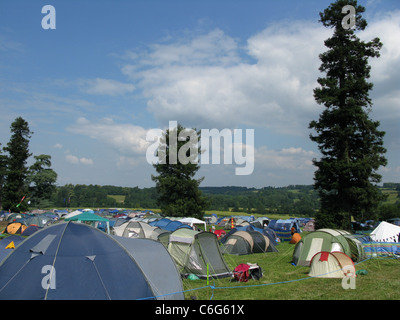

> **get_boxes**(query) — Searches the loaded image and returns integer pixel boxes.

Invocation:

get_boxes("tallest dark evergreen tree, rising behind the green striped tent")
[309,0,387,229]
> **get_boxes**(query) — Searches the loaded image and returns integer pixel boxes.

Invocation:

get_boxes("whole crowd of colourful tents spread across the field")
[0,206,400,300]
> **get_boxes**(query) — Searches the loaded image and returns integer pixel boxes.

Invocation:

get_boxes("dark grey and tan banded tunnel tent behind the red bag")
[220,228,278,255]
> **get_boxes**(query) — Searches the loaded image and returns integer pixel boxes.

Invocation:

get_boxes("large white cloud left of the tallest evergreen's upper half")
[123,22,328,133]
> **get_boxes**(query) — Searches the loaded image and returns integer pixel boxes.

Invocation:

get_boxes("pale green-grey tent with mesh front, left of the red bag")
[168,228,231,278]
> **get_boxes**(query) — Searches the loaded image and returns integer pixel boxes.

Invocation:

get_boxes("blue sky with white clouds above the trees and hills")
[0,0,400,188]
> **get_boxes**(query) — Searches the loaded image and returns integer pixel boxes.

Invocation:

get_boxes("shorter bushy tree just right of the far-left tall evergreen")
[28,154,57,206]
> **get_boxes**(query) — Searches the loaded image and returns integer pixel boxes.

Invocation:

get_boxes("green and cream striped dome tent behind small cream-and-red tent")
[293,229,365,266]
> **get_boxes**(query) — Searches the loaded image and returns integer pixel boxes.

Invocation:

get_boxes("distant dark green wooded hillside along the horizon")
[50,183,400,216]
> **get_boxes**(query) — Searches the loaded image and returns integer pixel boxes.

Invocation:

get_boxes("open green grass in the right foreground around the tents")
[183,242,400,300]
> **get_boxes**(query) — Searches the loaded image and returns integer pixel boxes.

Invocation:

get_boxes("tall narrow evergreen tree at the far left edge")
[3,117,33,212]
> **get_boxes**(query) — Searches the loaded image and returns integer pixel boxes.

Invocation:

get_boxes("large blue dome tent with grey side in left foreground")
[0,221,183,300]
